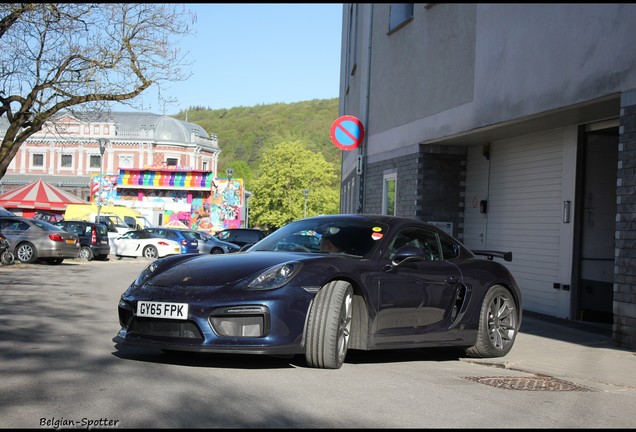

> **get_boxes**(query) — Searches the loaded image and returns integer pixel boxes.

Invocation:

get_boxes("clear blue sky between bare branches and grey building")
[122,3,342,115]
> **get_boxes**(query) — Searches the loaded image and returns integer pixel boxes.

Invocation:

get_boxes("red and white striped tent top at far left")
[0,180,86,212]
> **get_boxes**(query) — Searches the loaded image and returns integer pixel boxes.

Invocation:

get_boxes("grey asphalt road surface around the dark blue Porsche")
[0,258,636,428]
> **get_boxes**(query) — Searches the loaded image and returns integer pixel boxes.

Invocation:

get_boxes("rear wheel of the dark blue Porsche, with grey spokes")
[466,285,519,358]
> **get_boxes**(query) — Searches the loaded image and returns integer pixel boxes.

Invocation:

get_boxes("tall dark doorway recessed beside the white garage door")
[574,121,619,324]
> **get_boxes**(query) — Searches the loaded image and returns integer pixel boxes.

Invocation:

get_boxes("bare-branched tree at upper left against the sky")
[0,2,196,178]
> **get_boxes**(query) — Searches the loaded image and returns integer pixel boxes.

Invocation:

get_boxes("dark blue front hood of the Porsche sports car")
[146,252,328,288]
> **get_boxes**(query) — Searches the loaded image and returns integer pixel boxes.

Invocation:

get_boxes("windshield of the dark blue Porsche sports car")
[249,217,387,256]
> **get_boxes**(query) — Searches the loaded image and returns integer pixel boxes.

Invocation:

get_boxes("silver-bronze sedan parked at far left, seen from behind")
[0,216,80,264]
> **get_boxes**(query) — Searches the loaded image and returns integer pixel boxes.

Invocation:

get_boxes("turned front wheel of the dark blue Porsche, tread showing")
[305,281,353,369]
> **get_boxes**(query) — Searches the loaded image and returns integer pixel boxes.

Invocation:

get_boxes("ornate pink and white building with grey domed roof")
[0,112,221,202]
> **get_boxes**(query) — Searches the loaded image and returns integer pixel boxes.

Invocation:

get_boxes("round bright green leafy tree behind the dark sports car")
[250,141,340,228]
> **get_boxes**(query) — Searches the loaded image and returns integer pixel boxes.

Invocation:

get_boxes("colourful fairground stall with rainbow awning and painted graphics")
[91,166,245,232]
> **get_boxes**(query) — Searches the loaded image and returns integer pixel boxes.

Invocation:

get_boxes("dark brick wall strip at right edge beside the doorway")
[613,90,636,348]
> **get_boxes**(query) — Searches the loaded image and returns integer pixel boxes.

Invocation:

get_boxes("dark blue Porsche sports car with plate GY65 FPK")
[113,214,522,369]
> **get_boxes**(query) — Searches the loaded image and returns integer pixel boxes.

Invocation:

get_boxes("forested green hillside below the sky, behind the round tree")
[174,98,342,174]
